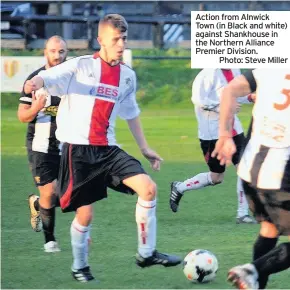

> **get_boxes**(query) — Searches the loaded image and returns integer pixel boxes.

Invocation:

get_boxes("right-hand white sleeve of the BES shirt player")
[118,73,140,120]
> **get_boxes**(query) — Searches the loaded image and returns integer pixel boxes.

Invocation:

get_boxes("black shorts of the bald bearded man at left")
[28,150,60,186]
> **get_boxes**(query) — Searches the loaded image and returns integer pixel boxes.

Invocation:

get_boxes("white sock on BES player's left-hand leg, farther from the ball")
[70,218,91,270]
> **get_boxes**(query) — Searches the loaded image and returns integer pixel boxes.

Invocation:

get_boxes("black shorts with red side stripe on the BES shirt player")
[57,143,146,212]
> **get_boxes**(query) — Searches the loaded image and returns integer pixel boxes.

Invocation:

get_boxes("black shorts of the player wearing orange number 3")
[242,180,290,236]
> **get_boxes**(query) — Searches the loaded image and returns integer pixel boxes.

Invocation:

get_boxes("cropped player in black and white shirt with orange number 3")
[212,69,290,289]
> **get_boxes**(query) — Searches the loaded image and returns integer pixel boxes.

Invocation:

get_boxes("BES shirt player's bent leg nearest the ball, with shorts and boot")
[106,147,182,267]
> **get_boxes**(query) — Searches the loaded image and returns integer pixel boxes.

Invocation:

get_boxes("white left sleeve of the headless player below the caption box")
[191,69,220,111]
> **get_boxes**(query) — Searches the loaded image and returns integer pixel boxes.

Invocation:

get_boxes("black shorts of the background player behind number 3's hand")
[200,133,245,173]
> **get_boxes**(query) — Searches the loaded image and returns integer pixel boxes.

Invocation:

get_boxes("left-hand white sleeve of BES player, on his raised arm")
[38,57,80,97]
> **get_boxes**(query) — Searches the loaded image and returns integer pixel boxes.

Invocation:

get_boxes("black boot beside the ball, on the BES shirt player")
[136,250,182,268]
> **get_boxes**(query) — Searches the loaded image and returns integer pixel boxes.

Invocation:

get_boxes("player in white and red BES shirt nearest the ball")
[25,14,181,282]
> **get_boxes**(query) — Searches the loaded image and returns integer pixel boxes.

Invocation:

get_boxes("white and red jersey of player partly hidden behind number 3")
[191,69,250,140]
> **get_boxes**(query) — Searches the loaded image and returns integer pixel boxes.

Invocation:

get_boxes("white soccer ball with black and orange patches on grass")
[183,250,218,283]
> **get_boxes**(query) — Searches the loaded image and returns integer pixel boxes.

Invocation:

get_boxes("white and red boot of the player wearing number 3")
[228,264,259,290]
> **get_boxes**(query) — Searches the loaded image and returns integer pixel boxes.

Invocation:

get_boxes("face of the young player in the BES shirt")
[98,26,127,60]
